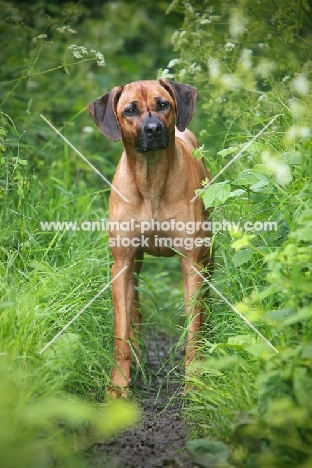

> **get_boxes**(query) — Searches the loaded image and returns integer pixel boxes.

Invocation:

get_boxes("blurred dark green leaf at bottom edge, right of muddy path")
[186,439,230,468]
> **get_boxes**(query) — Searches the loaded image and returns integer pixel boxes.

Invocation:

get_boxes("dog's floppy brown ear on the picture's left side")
[88,86,122,141]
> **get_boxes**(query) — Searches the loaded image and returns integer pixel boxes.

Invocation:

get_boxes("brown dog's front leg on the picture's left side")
[109,248,135,397]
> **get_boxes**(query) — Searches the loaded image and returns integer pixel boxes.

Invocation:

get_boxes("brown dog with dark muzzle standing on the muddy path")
[88,80,211,396]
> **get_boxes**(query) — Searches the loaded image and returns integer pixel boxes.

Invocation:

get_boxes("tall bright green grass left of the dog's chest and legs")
[0,130,137,468]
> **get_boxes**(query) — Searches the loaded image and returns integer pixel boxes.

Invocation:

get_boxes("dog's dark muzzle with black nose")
[135,117,169,153]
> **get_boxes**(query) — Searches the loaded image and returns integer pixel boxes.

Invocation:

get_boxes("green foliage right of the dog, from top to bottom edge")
[167,0,312,467]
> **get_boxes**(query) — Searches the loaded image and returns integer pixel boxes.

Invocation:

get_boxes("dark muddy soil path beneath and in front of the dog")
[84,333,193,468]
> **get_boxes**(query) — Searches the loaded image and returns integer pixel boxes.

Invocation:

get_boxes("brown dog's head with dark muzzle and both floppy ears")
[88,80,197,153]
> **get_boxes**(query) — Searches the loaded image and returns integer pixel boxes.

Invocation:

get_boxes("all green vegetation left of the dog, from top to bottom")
[0,0,183,460]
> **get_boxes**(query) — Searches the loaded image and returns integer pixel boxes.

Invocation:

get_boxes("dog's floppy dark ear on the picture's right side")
[159,80,197,132]
